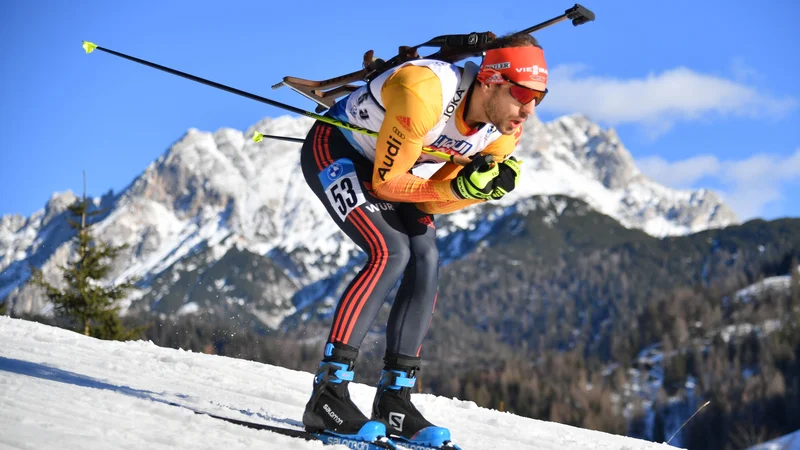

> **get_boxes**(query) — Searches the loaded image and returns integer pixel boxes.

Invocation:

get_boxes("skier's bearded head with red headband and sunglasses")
[475,33,547,134]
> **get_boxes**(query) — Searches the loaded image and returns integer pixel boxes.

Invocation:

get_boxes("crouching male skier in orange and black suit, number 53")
[301,33,547,447]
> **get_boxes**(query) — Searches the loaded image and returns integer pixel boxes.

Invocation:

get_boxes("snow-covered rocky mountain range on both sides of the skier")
[0,112,736,314]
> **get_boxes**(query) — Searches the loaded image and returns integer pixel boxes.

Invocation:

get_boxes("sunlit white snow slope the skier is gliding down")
[0,316,674,450]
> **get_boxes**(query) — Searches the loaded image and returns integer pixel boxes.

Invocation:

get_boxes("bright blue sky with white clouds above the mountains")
[0,0,800,220]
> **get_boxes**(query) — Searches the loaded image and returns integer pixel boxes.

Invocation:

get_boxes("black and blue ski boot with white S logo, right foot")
[372,354,460,450]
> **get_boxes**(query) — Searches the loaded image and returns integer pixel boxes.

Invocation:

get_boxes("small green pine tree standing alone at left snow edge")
[30,175,143,340]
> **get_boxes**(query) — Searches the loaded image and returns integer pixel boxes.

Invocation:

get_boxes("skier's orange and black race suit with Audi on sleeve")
[301,61,521,356]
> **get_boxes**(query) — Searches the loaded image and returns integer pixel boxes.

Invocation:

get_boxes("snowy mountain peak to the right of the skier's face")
[517,116,737,237]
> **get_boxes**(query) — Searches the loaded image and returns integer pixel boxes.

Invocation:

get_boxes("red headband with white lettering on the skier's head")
[478,45,547,91]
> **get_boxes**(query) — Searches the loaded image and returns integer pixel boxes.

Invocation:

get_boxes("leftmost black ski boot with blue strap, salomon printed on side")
[303,343,387,442]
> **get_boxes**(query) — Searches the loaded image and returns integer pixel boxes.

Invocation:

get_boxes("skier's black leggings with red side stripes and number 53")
[301,122,439,356]
